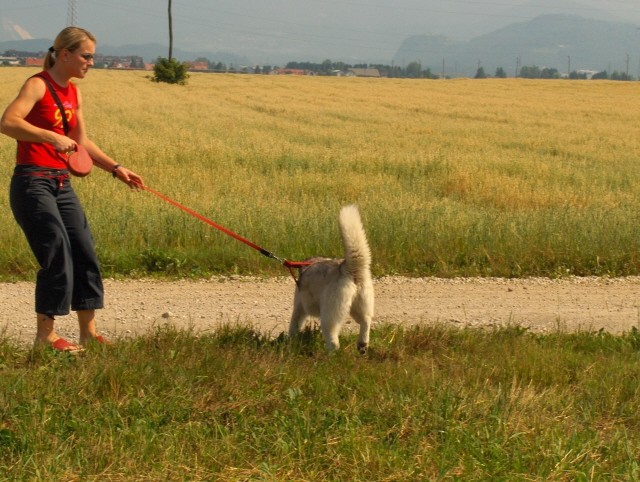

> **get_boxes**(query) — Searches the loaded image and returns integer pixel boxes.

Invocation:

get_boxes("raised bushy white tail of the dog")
[339,205,371,283]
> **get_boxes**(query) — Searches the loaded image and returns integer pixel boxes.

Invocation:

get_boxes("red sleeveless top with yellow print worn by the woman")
[17,71,78,169]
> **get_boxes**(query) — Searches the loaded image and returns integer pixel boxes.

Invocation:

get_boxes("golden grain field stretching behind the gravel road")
[0,68,640,279]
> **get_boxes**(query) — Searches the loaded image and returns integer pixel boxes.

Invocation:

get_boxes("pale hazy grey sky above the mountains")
[0,0,640,59]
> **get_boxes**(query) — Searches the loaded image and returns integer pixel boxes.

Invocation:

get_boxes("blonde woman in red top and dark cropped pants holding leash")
[0,27,144,352]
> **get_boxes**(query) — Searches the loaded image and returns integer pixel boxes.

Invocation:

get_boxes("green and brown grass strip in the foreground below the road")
[0,325,640,481]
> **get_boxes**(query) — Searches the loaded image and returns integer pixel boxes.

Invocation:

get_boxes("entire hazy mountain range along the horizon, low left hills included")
[0,14,640,77]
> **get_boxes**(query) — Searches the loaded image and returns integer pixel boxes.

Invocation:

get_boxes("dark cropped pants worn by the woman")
[10,166,104,317]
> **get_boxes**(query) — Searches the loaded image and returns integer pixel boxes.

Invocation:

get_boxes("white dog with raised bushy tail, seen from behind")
[289,205,373,353]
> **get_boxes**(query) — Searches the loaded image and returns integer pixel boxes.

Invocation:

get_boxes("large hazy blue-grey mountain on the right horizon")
[393,14,640,77]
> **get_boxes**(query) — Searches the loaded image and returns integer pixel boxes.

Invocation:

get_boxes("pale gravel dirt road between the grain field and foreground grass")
[0,277,640,343]
